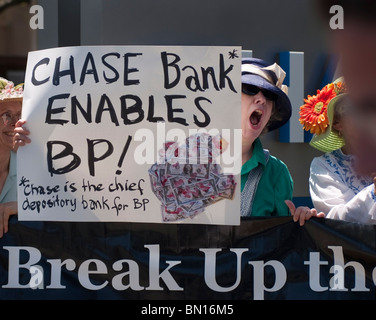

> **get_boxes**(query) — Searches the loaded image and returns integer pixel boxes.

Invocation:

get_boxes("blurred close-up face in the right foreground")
[334,21,376,174]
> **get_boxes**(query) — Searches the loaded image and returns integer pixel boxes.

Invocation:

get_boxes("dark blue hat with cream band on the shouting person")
[242,58,292,131]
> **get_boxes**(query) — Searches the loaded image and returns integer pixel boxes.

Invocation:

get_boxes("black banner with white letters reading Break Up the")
[0,217,376,300]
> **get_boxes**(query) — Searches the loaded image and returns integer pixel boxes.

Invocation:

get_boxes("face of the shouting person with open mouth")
[241,91,273,148]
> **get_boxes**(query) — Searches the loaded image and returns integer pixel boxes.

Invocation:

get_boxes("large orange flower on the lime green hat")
[299,83,337,134]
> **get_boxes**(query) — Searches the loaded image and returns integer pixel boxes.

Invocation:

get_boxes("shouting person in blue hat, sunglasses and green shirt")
[241,58,293,217]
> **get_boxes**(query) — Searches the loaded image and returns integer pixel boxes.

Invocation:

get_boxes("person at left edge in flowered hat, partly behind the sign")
[0,77,23,238]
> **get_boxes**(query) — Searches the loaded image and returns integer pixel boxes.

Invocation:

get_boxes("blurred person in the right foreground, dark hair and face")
[318,0,376,175]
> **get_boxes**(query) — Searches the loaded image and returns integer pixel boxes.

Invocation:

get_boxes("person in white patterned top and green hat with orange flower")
[287,77,376,225]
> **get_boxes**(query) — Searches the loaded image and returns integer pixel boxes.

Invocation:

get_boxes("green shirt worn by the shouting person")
[241,139,293,217]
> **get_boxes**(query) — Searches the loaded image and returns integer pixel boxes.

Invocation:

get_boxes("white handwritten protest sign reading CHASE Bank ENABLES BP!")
[17,46,241,225]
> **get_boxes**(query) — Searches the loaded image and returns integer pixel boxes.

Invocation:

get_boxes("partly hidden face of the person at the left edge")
[0,101,22,149]
